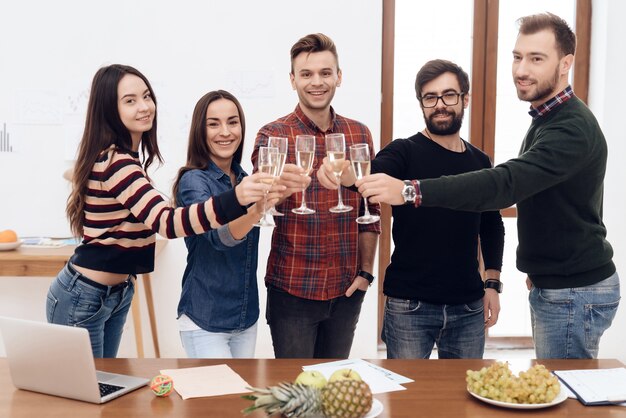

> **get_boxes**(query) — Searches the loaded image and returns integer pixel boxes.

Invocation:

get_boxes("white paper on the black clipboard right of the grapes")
[554,367,626,405]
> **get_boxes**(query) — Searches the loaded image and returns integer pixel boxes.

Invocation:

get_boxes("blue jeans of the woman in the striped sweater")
[46,264,135,358]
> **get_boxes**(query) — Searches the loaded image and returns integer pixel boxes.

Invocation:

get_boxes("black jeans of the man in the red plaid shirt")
[265,287,365,359]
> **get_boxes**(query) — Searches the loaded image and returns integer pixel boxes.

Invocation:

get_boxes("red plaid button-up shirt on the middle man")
[252,105,380,300]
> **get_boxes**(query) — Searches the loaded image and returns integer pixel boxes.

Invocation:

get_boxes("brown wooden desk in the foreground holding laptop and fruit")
[0,359,626,418]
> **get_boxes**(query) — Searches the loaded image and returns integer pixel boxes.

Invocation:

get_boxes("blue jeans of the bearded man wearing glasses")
[382,297,485,359]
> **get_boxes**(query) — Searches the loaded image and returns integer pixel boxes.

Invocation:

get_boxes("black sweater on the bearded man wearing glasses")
[372,133,504,304]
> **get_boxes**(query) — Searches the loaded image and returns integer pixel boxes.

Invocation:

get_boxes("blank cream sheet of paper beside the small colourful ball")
[161,364,251,399]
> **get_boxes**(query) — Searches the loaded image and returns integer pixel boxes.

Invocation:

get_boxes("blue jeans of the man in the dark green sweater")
[528,272,620,359]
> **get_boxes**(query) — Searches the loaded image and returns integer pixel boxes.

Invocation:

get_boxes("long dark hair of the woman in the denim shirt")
[172,90,246,204]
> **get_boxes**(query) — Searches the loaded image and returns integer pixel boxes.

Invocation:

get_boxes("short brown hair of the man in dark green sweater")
[517,13,576,58]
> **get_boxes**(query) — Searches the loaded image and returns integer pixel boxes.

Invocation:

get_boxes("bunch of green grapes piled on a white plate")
[465,362,561,404]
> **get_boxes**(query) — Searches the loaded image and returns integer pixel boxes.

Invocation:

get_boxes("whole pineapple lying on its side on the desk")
[242,379,373,418]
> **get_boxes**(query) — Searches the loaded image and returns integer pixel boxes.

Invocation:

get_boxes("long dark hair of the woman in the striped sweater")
[65,64,163,236]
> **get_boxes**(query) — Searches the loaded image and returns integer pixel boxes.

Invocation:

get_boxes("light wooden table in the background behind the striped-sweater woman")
[0,239,167,358]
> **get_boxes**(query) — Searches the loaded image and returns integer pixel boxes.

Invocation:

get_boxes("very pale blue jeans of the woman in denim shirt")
[180,322,257,358]
